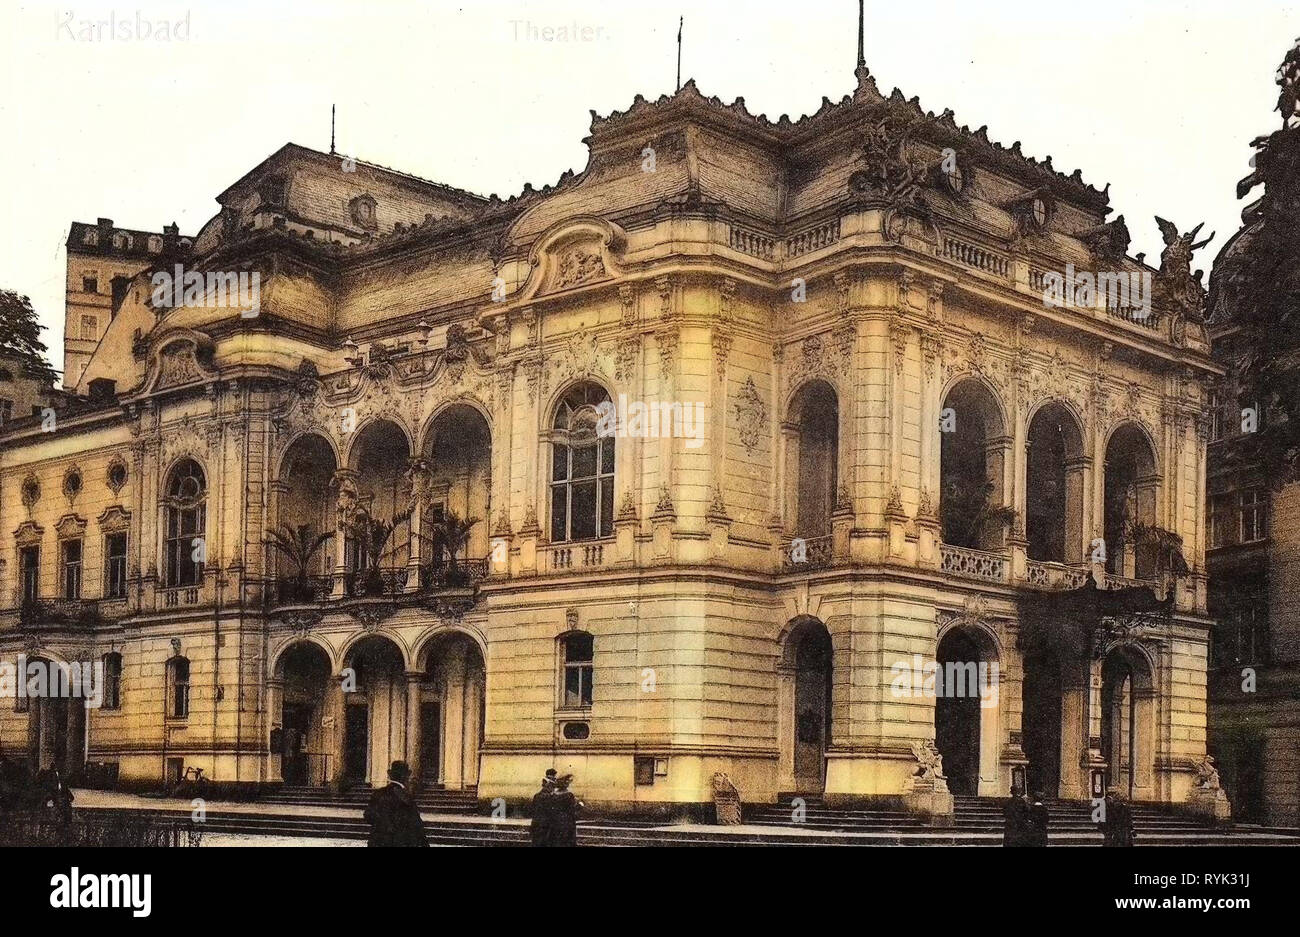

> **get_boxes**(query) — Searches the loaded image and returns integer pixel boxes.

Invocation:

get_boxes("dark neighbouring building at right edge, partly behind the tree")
[1206,215,1300,827]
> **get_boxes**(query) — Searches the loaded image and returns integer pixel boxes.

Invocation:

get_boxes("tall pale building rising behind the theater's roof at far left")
[64,218,186,394]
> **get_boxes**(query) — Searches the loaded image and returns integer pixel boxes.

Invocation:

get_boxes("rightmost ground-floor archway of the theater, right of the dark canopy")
[1101,645,1156,801]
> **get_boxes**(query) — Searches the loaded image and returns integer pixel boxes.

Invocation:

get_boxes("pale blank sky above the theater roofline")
[0,0,1300,368]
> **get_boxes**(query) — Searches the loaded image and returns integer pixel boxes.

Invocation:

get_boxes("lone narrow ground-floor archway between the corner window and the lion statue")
[779,616,835,794]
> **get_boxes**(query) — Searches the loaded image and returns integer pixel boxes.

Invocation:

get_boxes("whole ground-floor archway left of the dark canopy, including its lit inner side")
[935,624,1001,795]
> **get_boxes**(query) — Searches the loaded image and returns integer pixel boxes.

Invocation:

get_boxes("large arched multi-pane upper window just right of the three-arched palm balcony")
[551,383,614,542]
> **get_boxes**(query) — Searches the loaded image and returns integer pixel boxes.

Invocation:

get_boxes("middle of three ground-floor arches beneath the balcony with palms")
[341,634,407,785]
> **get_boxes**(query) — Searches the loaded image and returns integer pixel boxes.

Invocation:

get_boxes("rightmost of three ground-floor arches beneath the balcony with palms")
[410,630,488,790]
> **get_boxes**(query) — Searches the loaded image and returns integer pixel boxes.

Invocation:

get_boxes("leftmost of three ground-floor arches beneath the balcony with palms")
[272,641,333,786]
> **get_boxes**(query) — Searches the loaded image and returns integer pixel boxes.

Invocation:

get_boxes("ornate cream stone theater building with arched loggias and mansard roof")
[0,65,1221,814]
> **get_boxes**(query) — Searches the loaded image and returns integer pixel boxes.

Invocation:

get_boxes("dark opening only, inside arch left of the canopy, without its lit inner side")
[935,632,980,795]
